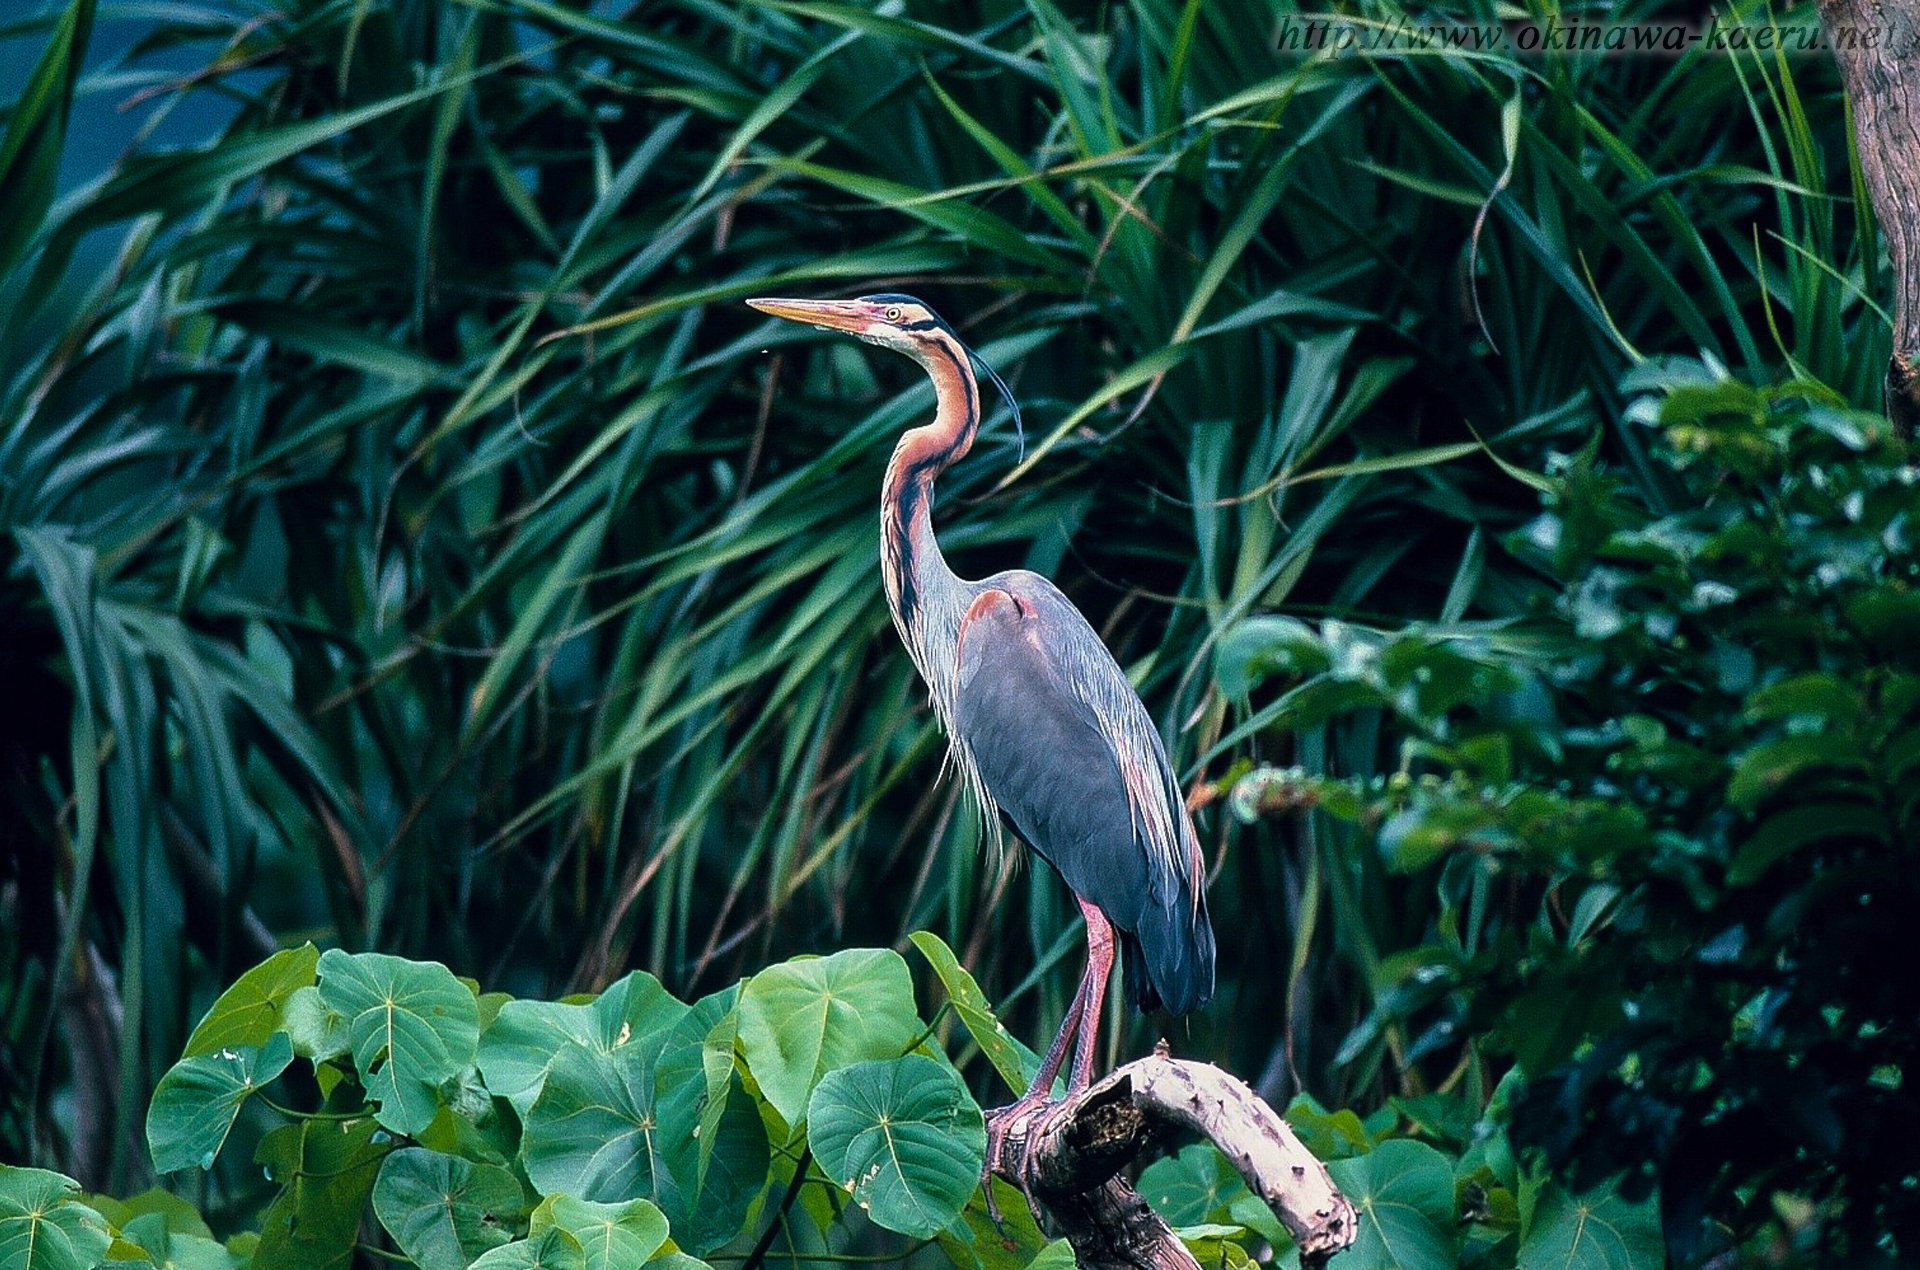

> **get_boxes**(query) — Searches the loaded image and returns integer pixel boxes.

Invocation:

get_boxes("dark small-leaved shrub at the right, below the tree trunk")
[1219,363,1920,1264]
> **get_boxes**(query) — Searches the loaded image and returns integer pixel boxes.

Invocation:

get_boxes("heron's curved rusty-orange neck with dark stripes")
[879,342,979,715]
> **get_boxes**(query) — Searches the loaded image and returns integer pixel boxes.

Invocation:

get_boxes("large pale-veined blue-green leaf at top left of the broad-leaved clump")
[319,949,480,1134]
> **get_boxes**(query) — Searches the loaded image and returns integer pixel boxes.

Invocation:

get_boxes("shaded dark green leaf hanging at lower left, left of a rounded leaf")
[250,1116,392,1270]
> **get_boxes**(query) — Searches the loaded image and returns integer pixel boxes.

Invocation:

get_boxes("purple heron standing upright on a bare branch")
[747,294,1213,1109]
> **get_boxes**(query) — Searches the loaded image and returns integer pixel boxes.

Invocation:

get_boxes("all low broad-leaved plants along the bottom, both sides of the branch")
[0,932,1659,1270]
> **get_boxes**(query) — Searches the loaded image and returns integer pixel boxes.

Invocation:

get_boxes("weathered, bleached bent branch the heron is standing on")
[987,1043,1357,1270]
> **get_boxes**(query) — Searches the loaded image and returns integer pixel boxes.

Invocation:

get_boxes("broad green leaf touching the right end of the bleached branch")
[1327,1137,1455,1270]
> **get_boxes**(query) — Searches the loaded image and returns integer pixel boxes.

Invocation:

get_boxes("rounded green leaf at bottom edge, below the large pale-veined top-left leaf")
[372,1147,524,1270]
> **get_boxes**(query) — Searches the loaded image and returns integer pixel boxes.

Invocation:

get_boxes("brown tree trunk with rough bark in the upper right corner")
[1818,0,1920,436]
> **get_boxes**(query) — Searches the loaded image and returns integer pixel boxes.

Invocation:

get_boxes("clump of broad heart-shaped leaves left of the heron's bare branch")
[0,936,1021,1270]
